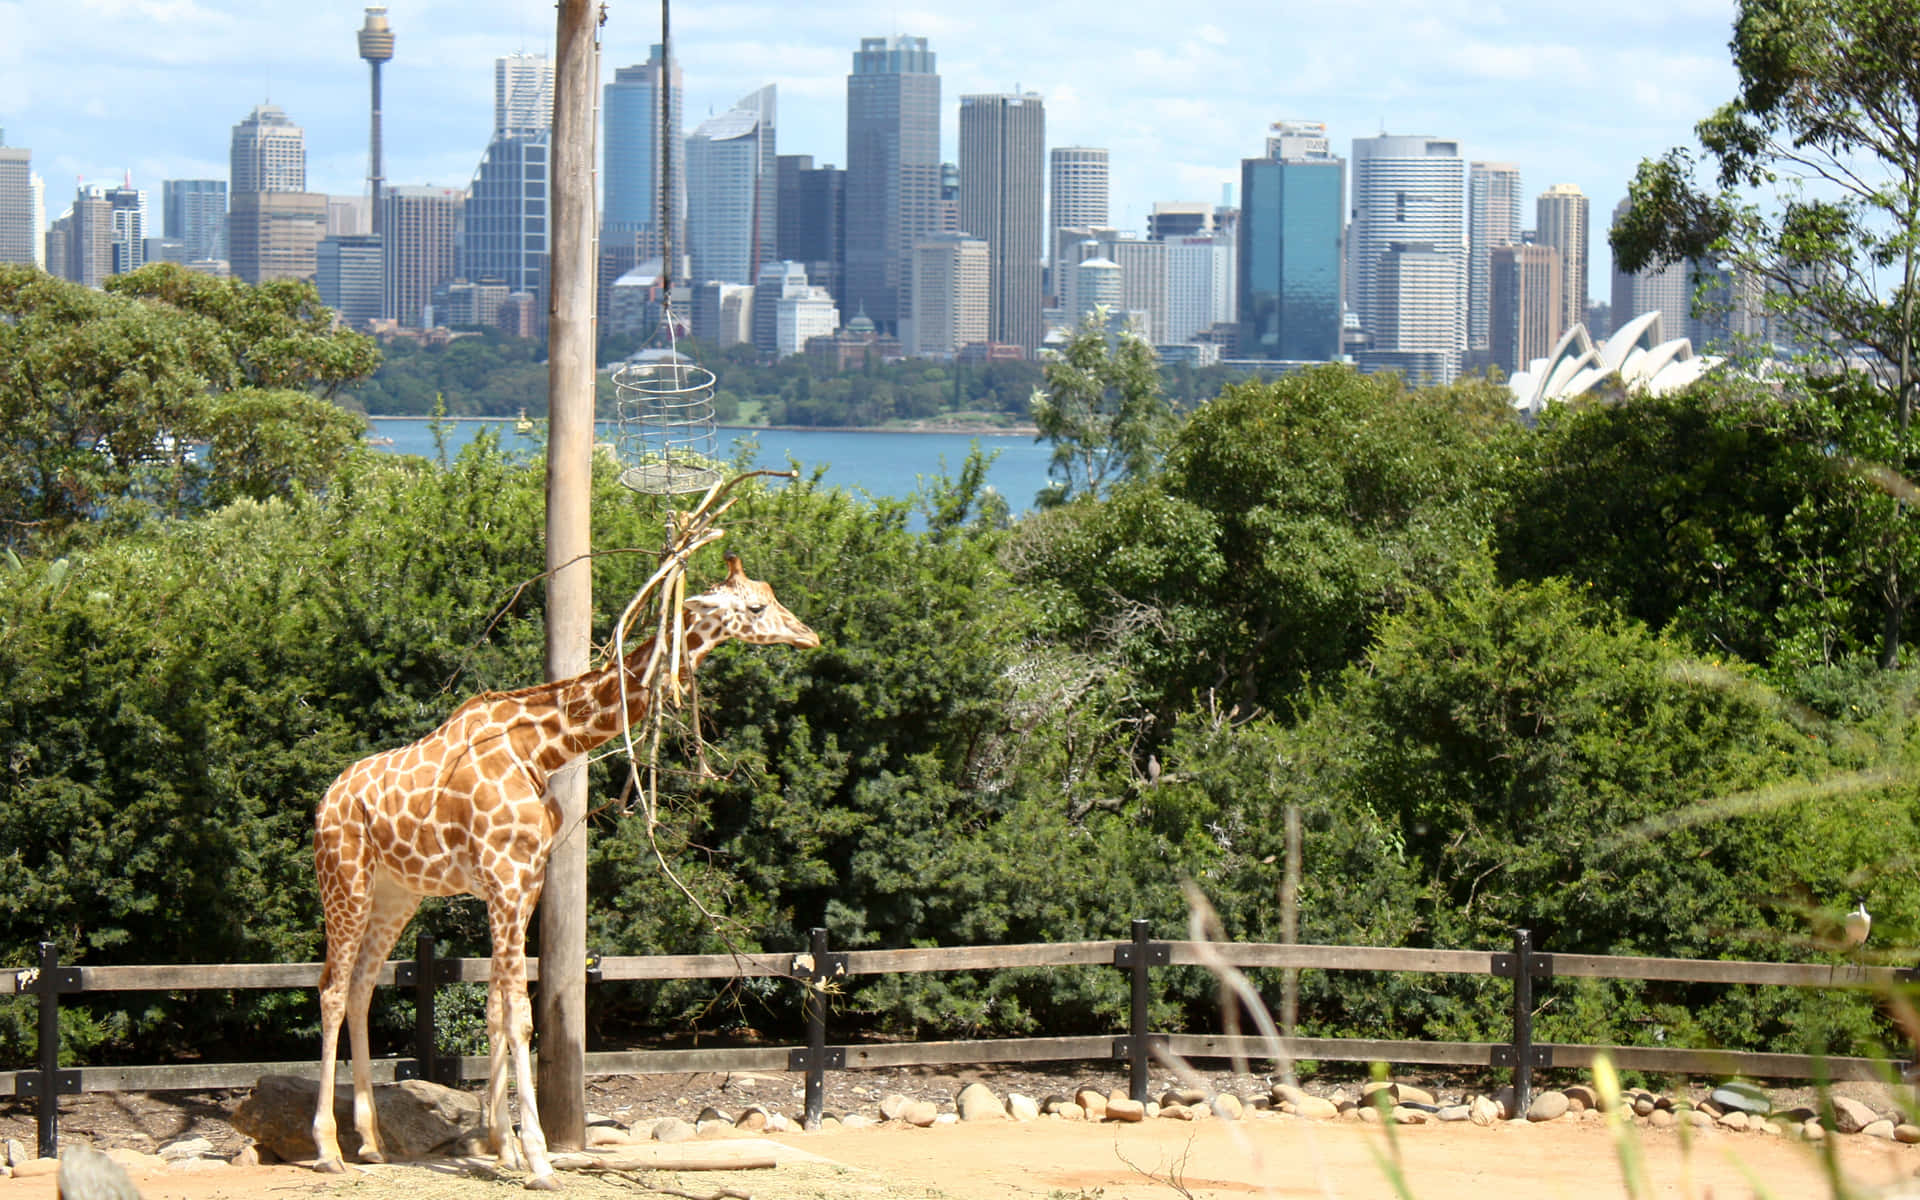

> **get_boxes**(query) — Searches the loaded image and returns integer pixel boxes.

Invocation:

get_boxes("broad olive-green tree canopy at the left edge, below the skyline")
[0,265,374,545]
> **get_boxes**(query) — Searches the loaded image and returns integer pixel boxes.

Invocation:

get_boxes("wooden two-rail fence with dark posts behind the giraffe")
[0,922,1914,1156]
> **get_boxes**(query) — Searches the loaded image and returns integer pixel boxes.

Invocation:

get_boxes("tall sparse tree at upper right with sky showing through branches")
[1611,0,1920,666]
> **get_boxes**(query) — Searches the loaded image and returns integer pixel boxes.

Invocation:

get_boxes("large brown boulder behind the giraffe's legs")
[232,1075,480,1160]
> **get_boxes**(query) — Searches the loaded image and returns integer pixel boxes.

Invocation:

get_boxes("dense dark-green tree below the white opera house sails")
[1498,376,1920,668]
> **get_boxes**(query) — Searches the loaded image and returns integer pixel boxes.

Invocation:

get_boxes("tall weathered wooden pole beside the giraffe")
[534,0,599,1150]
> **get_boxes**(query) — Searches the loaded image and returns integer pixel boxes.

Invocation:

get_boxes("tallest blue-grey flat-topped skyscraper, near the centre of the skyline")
[847,36,940,332]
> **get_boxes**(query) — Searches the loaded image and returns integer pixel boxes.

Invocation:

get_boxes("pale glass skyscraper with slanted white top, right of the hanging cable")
[687,108,778,284]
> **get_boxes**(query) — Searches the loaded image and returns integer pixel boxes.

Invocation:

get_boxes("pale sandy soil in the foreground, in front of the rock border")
[0,1119,1920,1200]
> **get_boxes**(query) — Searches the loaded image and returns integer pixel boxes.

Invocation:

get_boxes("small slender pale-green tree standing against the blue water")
[1031,317,1173,505]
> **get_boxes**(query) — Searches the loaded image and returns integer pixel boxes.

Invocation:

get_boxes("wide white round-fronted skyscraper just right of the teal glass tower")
[1346,134,1467,357]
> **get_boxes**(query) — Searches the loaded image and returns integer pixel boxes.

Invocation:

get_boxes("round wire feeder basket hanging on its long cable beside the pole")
[612,0,722,495]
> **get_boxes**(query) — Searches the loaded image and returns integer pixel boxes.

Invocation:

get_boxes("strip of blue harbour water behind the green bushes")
[367,417,1052,513]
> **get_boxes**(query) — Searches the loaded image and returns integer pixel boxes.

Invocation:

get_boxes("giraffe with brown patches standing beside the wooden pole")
[313,555,820,1190]
